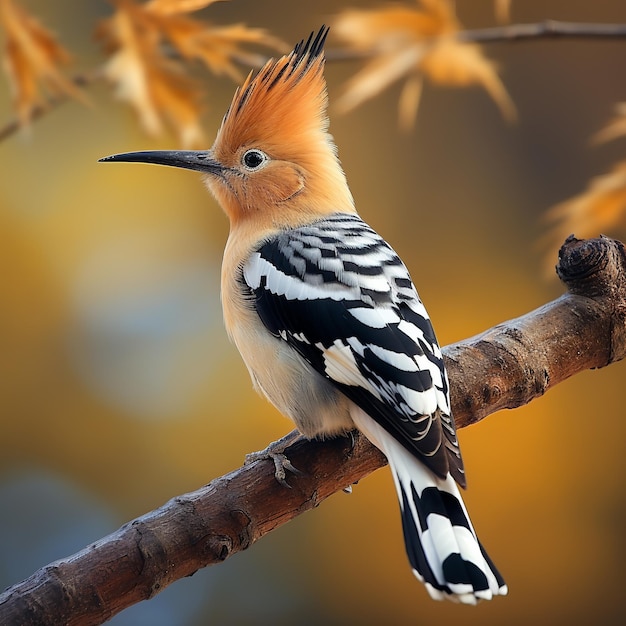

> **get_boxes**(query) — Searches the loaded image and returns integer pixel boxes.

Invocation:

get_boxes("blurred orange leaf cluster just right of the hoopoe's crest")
[333,0,516,129]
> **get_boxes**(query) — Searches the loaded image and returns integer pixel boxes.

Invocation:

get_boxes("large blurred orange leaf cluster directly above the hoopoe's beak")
[97,0,282,147]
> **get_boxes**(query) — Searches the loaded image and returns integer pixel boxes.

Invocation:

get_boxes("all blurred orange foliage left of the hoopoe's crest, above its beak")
[0,0,285,146]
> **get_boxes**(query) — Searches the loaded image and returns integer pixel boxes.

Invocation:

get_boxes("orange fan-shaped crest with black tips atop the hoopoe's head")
[213,27,332,162]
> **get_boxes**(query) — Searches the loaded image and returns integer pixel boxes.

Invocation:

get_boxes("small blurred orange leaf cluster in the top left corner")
[0,0,85,125]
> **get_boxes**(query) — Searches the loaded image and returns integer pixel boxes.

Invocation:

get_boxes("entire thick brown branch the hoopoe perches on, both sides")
[0,237,626,626]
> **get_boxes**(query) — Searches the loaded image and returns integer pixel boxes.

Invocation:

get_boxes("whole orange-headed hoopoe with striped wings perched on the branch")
[102,28,507,604]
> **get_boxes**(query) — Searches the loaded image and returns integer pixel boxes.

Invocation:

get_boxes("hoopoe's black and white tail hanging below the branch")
[351,407,507,604]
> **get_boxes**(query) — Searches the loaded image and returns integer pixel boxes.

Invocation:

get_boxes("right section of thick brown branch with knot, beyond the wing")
[444,237,626,428]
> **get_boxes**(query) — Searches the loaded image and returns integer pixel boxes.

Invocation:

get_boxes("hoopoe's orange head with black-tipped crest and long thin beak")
[102,27,354,225]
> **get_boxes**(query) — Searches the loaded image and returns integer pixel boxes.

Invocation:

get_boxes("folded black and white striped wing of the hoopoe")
[243,214,465,485]
